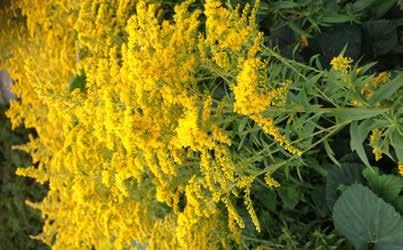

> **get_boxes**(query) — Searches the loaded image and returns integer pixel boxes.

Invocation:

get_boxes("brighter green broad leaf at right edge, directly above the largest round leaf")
[362,168,403,211]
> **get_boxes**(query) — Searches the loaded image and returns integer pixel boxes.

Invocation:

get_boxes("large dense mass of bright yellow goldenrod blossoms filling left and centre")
[0,0,301,249]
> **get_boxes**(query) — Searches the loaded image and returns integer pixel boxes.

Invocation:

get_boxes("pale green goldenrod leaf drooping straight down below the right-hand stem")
[350,120,372,166]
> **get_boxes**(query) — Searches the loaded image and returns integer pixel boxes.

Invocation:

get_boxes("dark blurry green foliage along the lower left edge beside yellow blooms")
[0,106,47,250]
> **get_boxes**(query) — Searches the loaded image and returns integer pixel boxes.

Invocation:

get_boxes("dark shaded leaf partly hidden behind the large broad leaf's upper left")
[326,163,364,209]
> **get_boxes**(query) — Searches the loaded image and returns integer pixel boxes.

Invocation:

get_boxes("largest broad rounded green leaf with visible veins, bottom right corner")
[333,184,403,250]
